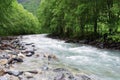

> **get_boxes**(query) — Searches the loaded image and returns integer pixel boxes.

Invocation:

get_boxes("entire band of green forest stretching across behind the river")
[0,0,120,47]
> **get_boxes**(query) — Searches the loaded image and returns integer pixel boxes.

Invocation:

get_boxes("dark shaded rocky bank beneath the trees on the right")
[47,35,120,50]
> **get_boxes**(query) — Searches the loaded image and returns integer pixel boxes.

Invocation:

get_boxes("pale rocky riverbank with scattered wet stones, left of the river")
[0,36,95,80]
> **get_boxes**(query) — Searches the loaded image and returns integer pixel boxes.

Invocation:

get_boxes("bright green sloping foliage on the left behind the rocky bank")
[0,0,39,35]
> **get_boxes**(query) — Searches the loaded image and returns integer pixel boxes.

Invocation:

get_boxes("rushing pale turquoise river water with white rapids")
[19,34,120,80]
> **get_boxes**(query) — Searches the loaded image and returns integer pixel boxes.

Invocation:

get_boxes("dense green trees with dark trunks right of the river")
[38,0,120,41]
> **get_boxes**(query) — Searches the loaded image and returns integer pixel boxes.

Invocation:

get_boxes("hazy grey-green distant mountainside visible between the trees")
[18,0,40,15]
